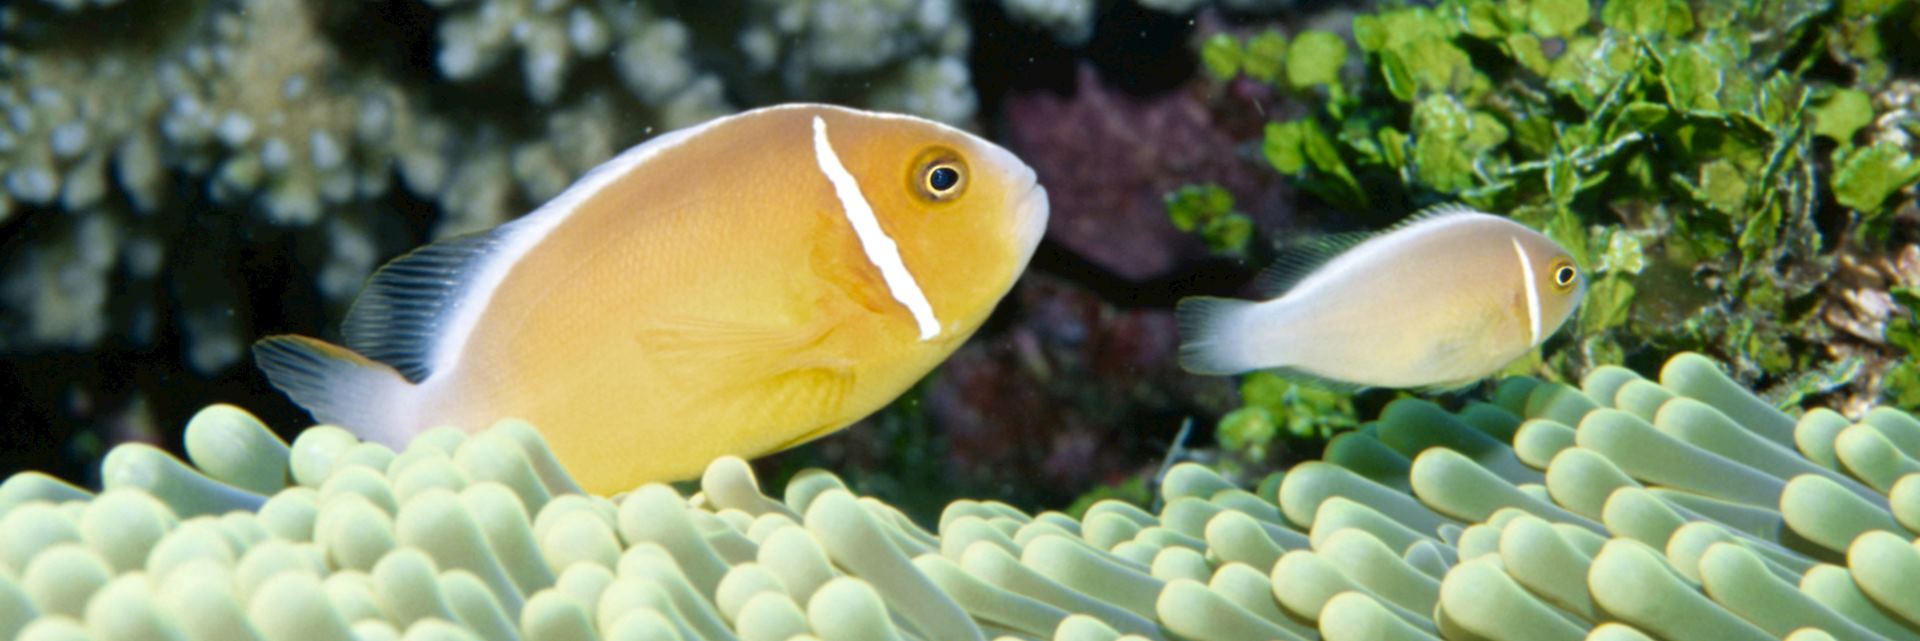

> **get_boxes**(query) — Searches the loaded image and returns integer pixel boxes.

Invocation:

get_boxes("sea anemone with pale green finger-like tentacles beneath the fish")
[0,355,1920,641]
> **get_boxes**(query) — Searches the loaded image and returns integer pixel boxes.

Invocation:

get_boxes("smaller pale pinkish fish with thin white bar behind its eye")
[1177,205,1586,390]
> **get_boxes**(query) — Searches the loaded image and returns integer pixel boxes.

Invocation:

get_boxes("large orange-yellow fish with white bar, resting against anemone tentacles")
[253,106,1046,493]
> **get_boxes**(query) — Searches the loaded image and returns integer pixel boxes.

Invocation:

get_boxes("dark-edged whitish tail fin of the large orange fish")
[253,334,413,451]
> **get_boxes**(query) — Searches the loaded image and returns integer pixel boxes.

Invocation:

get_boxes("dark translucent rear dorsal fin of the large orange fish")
[340,225,511,384]
